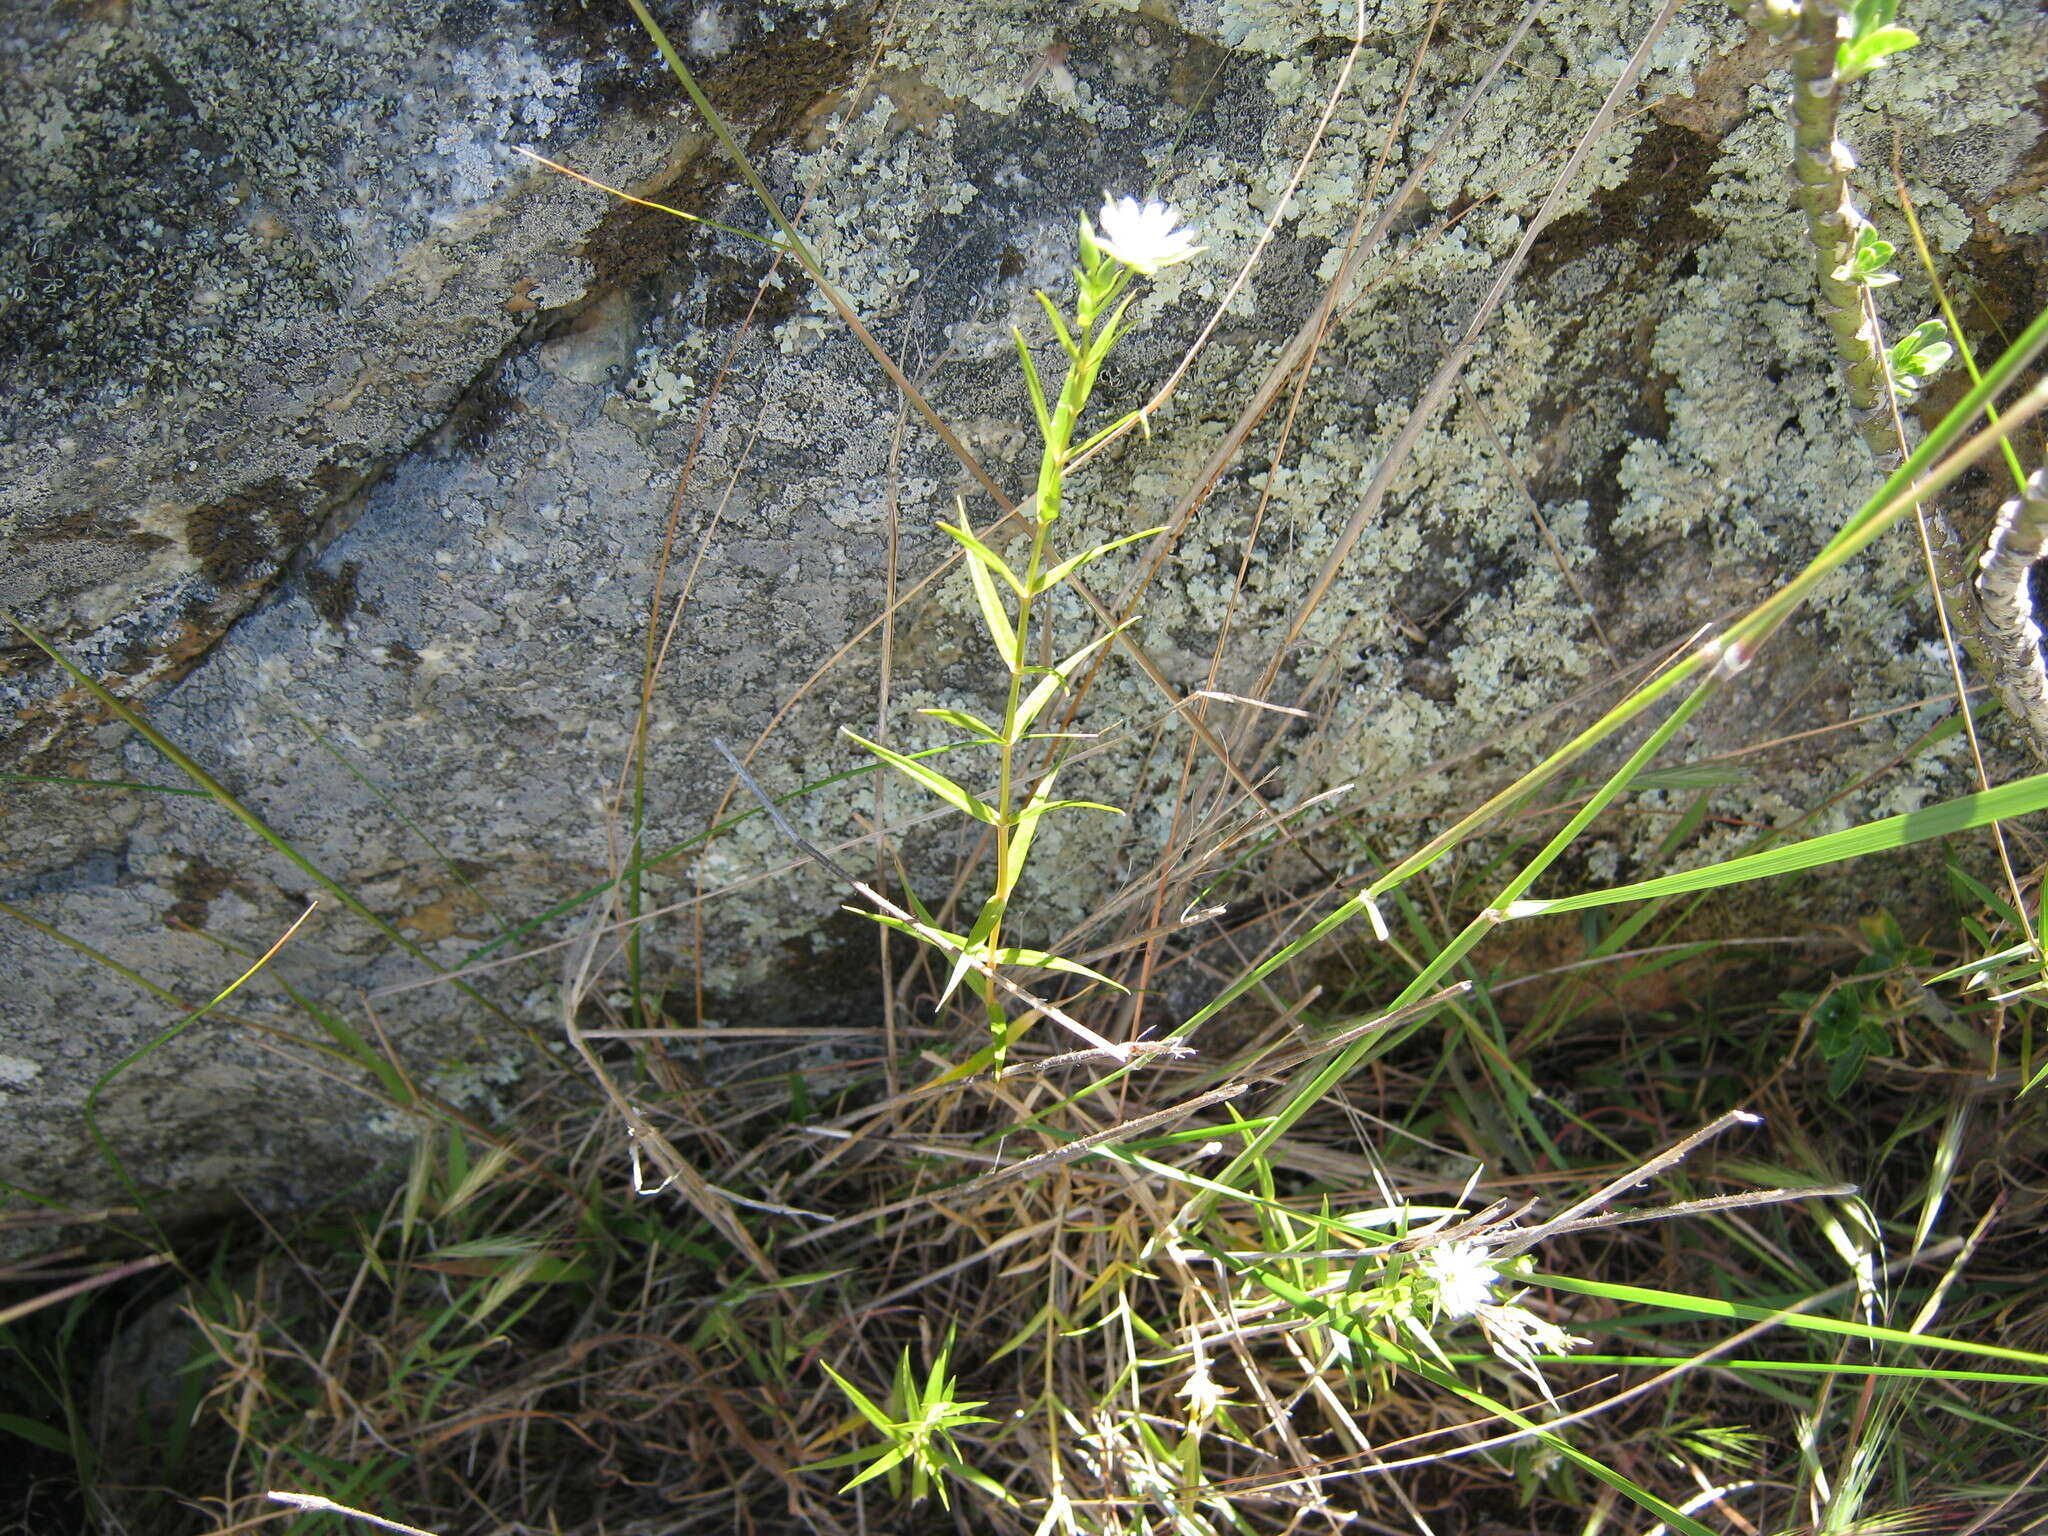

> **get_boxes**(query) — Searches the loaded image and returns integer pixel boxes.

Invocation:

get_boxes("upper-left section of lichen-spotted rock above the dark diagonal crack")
[0,0,850,774]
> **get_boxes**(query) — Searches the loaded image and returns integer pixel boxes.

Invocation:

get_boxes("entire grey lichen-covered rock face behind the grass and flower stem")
[0,0,2048,1208]
